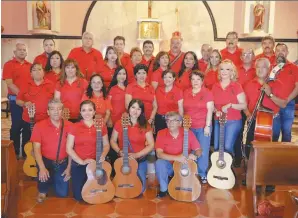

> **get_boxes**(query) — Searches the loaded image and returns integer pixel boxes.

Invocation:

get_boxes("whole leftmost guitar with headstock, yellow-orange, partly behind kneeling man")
[23,104,37,177]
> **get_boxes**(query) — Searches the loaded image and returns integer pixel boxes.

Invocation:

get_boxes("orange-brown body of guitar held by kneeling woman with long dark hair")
[113,157,142,198]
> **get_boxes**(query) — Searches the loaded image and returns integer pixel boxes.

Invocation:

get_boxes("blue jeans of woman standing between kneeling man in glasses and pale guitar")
[191,127,212,177]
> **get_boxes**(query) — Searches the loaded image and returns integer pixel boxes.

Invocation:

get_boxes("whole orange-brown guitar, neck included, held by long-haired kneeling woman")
[113,113,142,198]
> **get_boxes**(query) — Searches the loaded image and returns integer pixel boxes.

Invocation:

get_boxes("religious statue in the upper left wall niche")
[35,1,51,29]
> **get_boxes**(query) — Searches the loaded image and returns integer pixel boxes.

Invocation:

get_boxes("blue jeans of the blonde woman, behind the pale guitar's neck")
[214,120,242,156]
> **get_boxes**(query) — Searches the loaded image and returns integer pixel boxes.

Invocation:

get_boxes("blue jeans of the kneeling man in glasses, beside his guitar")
[155,159,174,192]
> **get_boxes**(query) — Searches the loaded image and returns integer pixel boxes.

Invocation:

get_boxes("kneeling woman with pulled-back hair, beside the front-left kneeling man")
[66,100,110,201]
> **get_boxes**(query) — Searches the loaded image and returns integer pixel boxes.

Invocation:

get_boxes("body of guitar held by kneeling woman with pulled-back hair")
[82,161,115,204]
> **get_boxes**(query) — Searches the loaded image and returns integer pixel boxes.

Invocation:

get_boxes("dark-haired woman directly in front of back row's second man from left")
[45,51,64,84]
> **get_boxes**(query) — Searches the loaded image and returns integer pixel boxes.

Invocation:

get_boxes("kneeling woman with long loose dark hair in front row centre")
[110,99,154,193]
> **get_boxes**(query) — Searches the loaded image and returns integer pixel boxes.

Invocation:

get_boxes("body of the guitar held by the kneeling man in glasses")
[168,160,201,202]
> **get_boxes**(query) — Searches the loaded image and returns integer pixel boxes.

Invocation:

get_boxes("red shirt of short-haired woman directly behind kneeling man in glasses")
[155,86,183,115]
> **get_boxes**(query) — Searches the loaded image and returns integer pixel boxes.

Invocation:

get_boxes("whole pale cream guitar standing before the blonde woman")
[207,113,235,189]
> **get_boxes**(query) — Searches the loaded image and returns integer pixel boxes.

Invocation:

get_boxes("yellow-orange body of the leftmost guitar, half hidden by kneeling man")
[23,142,37,177]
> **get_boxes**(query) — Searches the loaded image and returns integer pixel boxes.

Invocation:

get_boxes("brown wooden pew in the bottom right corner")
[246,142,298,217]
